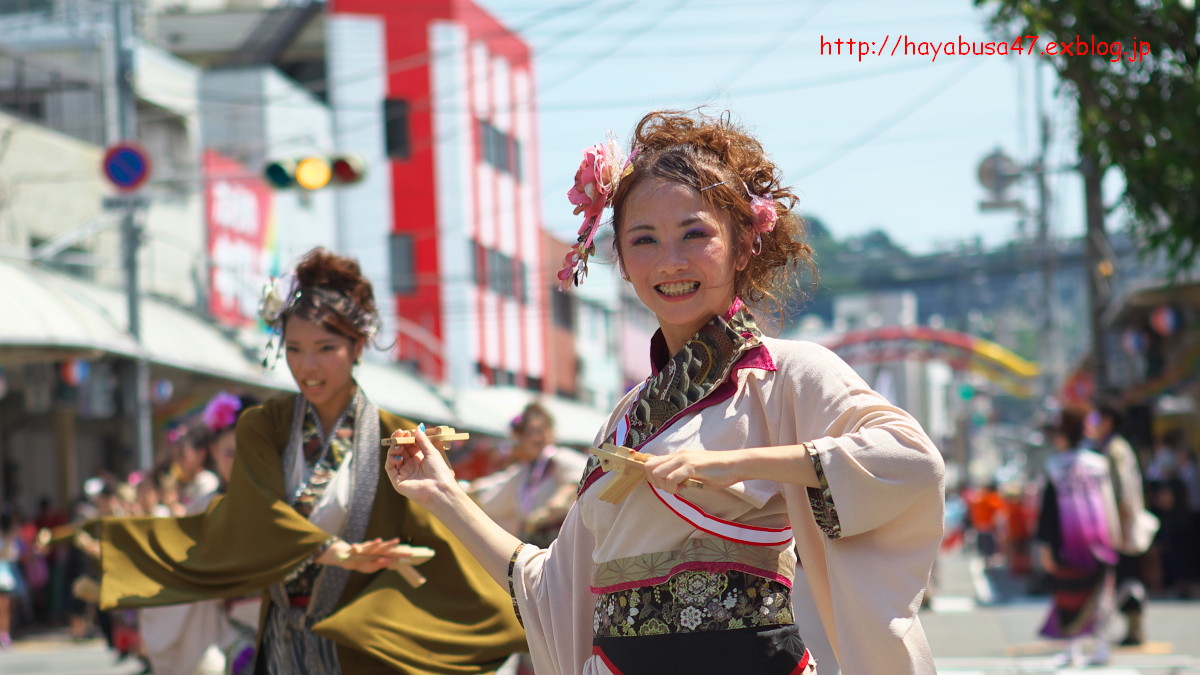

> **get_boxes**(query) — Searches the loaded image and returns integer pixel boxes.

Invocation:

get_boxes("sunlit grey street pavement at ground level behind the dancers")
[0,551,1200,675]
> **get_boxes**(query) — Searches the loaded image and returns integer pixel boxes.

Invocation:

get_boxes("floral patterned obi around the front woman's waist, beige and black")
[592,538,796,638]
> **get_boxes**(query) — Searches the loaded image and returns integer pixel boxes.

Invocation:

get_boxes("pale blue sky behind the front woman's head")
[479,0,1099,252]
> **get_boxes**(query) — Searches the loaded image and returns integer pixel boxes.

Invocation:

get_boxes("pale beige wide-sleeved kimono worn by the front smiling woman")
[512,333,944,675]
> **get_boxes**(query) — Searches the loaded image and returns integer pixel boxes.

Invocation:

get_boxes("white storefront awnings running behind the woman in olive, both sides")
[0,259,608,437]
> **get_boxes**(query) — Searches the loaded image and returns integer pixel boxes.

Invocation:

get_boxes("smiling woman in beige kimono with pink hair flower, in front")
[386,113,944,675]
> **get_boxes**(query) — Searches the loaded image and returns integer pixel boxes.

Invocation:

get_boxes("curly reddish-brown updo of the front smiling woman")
[612,110,816,310]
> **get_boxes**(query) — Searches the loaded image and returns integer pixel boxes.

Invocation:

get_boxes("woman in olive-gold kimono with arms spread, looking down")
[91,249,524,675]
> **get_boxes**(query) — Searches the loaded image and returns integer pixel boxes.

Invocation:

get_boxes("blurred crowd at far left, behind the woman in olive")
[0,393,256,673]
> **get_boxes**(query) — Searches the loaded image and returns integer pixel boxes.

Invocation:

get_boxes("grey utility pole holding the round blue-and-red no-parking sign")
[113,0,154,468]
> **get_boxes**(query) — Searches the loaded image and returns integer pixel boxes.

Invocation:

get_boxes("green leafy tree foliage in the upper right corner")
[974,0,1200,267]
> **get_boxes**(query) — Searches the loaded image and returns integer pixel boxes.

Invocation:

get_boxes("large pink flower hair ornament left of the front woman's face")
[558,135,640,291]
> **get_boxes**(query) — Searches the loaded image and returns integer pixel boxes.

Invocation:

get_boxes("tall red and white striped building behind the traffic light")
[326,0,550,390]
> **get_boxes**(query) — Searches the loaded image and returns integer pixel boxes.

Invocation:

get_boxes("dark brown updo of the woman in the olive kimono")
[287,246,379,342]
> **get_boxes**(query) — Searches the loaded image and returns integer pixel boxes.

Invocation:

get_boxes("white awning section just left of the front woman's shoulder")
[454,387,608,446]
